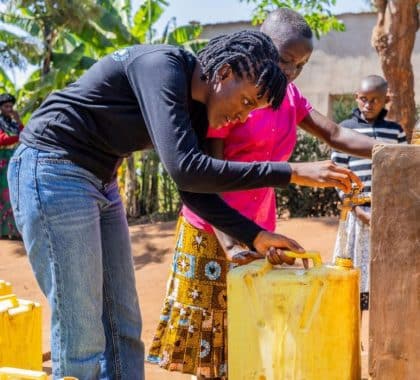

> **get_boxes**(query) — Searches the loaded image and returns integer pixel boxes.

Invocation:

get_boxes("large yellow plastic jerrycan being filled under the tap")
[228,253,361,380]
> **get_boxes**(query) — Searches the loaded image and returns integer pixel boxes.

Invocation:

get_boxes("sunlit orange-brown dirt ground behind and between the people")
[0,218,368,380]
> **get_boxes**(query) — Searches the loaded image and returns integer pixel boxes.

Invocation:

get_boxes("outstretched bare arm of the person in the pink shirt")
[299,110,376,158]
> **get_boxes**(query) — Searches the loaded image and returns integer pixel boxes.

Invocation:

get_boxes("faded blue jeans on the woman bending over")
[8,145,144,380]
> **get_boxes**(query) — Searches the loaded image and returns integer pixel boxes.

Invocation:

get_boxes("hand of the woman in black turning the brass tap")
[290,160,363,193]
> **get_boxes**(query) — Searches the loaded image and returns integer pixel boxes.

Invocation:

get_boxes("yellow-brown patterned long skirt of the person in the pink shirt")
[147,217,230,379]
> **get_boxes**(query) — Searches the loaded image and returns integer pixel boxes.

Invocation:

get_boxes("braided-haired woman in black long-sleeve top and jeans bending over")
[8,31,358,379]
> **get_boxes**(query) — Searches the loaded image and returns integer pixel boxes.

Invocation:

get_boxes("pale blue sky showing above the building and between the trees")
[0,0,369,86]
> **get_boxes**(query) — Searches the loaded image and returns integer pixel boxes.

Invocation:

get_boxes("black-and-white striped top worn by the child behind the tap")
[331,109,407,199]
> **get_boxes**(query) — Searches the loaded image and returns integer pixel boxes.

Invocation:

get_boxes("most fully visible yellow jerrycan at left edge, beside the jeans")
[0,294,42,371]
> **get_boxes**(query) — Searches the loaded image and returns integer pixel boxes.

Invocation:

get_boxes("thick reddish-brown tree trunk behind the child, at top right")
[372,0,419,138]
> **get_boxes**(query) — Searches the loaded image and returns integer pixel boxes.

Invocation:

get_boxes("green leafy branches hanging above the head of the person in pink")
[240,0,345,38]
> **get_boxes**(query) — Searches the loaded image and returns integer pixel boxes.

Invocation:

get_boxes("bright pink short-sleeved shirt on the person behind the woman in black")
[181,83,312,232]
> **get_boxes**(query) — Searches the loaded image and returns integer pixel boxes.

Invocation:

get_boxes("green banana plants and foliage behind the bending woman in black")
[0,0,205,217]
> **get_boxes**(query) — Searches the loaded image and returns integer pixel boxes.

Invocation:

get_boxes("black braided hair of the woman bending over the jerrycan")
[198,30,287,109]
